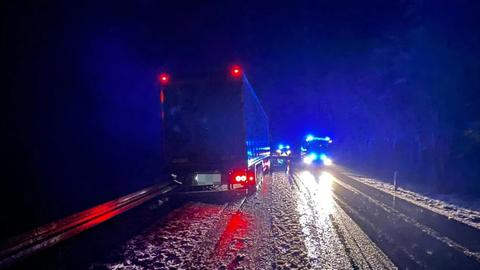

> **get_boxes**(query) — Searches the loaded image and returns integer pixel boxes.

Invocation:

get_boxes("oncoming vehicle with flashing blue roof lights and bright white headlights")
[301,135,333,166]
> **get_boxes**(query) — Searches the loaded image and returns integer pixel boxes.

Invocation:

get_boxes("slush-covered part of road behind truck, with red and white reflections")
[92,172,394,269]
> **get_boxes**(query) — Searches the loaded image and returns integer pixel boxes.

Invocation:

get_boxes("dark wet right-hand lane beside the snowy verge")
[333,170,480,269]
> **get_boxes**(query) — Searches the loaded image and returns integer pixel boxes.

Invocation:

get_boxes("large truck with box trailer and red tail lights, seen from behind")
[159,65,270,192]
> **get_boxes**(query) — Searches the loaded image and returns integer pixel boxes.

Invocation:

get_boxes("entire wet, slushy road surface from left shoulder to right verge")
[91,168,480,269]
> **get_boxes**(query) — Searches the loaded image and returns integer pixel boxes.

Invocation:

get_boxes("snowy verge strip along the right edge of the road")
[342,169,480,229]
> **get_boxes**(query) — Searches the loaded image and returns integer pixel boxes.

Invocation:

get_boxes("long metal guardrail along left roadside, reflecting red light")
[0,184,177,268]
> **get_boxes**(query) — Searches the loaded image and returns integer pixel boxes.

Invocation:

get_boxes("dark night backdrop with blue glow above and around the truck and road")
[2,0,480,236]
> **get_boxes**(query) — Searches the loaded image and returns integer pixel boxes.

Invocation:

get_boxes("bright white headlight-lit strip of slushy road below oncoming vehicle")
[295,172,396,269]
